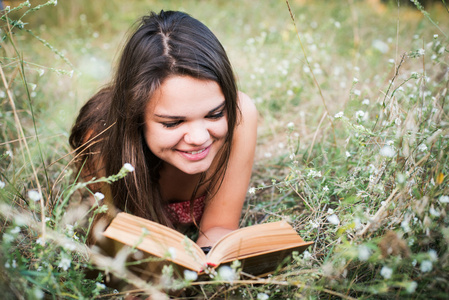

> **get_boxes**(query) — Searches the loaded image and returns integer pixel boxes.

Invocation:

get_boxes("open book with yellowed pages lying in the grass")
[103,212,313,275]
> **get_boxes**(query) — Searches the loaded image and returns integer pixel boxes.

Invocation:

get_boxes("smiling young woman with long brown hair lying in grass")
[70,11,257,247]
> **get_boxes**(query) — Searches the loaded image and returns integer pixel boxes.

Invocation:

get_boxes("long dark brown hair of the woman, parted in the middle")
[70,11,239,226]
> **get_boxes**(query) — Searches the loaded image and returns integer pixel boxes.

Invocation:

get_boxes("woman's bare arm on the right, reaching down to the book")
[197,92,257,247]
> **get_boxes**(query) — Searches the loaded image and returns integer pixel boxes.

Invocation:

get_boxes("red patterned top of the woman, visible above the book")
[167,196,206,225]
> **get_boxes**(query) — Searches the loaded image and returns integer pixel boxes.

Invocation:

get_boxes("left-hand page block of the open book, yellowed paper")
[103,213,206,272]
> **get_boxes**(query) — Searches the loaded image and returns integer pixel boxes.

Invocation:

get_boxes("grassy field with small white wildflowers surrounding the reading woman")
[0,0,449,299]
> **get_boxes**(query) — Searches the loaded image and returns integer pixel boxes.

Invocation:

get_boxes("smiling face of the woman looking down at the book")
[144,76,228,174]
